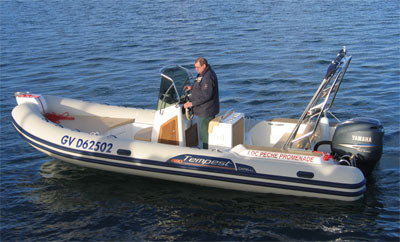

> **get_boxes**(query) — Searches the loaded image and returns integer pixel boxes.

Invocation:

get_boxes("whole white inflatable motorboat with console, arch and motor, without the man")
[12,48,384,201]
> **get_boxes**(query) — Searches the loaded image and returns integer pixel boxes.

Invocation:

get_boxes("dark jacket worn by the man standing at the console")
[191,65,219,117]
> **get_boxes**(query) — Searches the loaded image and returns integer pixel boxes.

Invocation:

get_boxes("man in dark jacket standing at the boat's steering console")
[184,57,219,149]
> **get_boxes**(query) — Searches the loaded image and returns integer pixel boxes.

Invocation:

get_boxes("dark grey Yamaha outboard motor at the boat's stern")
[331,118,384,176]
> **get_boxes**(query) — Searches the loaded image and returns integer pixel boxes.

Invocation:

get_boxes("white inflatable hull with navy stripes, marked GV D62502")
[12,93,366,201]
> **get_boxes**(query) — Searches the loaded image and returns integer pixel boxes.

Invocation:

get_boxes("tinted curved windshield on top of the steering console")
[157,65,192,110]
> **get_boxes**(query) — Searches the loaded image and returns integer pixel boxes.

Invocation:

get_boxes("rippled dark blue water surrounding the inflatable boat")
[0,0,400,241]
